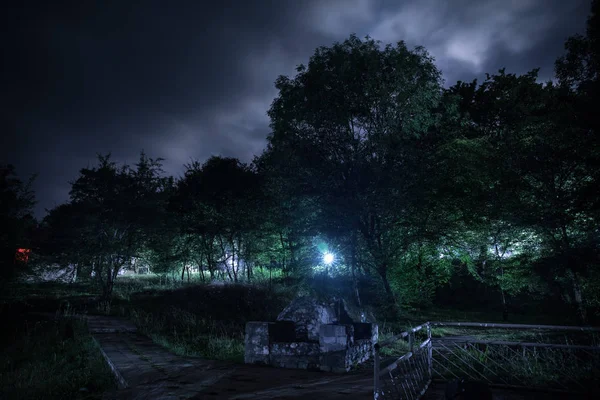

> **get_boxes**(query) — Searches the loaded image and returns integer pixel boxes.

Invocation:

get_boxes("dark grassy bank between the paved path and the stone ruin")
[120,284,291,362]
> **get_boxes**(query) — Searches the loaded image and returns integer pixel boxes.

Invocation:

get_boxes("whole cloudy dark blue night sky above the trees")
[0,0,590,217]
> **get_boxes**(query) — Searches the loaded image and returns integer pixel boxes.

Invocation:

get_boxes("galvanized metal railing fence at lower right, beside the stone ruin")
[374,322,600,399]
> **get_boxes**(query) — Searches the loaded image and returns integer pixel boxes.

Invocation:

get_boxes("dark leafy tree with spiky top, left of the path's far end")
[45,153,170,299]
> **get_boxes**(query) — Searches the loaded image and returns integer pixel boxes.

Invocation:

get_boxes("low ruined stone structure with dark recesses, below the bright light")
[244,297,378,372]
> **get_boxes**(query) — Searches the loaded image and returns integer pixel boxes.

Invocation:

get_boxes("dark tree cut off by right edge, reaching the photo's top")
[555,0,600,317]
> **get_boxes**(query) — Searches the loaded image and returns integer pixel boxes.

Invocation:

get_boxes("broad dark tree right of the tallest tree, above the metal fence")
[446,65,598,319]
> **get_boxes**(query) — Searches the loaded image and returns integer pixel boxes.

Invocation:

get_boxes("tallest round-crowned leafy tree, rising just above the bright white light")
[262,35,442,297]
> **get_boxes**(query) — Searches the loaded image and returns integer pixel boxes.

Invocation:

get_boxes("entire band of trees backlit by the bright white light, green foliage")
[22,1,600,320]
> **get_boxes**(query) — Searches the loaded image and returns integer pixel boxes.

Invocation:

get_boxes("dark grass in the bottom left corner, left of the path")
[0,313,115,399]
